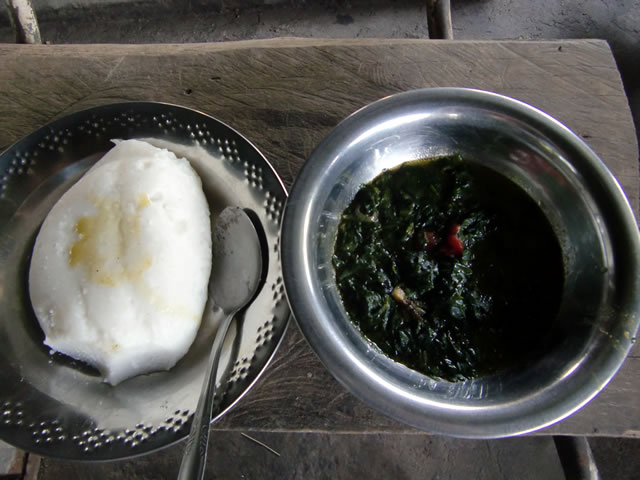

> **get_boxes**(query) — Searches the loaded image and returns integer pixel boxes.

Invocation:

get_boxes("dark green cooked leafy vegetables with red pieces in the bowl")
[333,156,564,381]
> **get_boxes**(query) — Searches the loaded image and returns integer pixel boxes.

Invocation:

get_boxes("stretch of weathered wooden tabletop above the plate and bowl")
[0,39,638,207]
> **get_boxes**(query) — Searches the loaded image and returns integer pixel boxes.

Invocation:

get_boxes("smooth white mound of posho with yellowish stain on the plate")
[29,140,212,385]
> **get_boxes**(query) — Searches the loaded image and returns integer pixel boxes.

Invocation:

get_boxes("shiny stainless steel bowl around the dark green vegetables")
[281,88,640,438]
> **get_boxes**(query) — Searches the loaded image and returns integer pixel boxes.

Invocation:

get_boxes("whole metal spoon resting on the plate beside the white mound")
[178,207,262,480]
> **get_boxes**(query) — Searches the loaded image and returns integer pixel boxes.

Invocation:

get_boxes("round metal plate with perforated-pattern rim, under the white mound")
[0,102,289,460]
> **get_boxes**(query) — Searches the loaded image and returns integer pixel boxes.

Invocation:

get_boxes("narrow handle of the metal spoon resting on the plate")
[178,312,235,480]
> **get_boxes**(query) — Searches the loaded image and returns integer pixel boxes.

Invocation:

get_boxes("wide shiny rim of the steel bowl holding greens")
[280,87,640,438]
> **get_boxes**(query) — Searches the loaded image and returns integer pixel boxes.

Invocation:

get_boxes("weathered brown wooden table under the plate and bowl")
[0,39,640,437]
